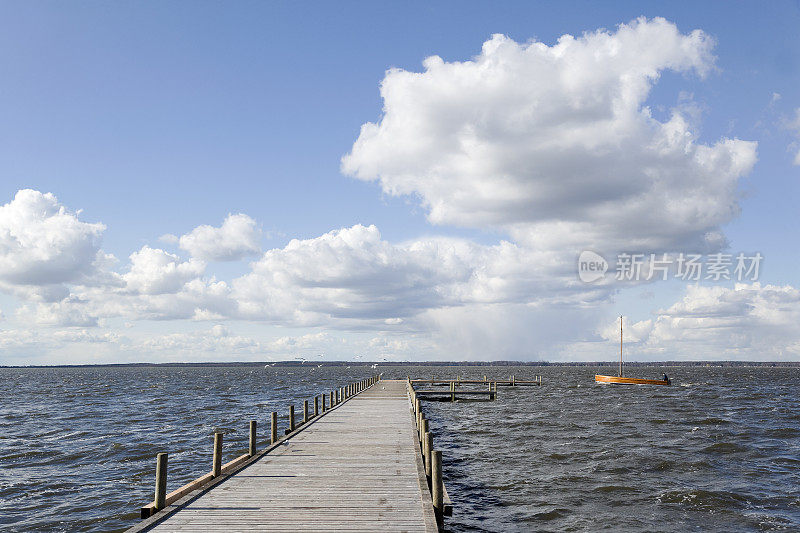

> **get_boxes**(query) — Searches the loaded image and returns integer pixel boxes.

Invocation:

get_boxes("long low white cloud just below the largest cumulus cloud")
[232,225,590,327]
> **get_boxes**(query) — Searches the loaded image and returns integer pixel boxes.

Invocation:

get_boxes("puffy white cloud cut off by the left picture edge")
[0,189,106,288]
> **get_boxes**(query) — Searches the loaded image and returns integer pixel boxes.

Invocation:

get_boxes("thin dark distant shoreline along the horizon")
[0,361,800,368]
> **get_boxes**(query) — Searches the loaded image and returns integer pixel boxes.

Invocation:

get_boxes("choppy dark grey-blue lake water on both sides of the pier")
[0,366,800,532]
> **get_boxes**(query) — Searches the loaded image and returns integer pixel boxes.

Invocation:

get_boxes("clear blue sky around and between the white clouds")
[0,2,800,364]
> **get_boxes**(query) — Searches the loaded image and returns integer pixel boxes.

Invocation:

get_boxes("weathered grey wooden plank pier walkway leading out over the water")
[134,380,440,533]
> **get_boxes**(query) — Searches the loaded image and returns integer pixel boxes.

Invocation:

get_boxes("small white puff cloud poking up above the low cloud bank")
[179,214,261,261]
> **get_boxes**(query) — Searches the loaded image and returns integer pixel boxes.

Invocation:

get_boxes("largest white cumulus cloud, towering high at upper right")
[342,19,756,253]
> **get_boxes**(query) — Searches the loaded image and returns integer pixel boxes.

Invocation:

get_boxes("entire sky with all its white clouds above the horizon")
[0,1,800,365]
